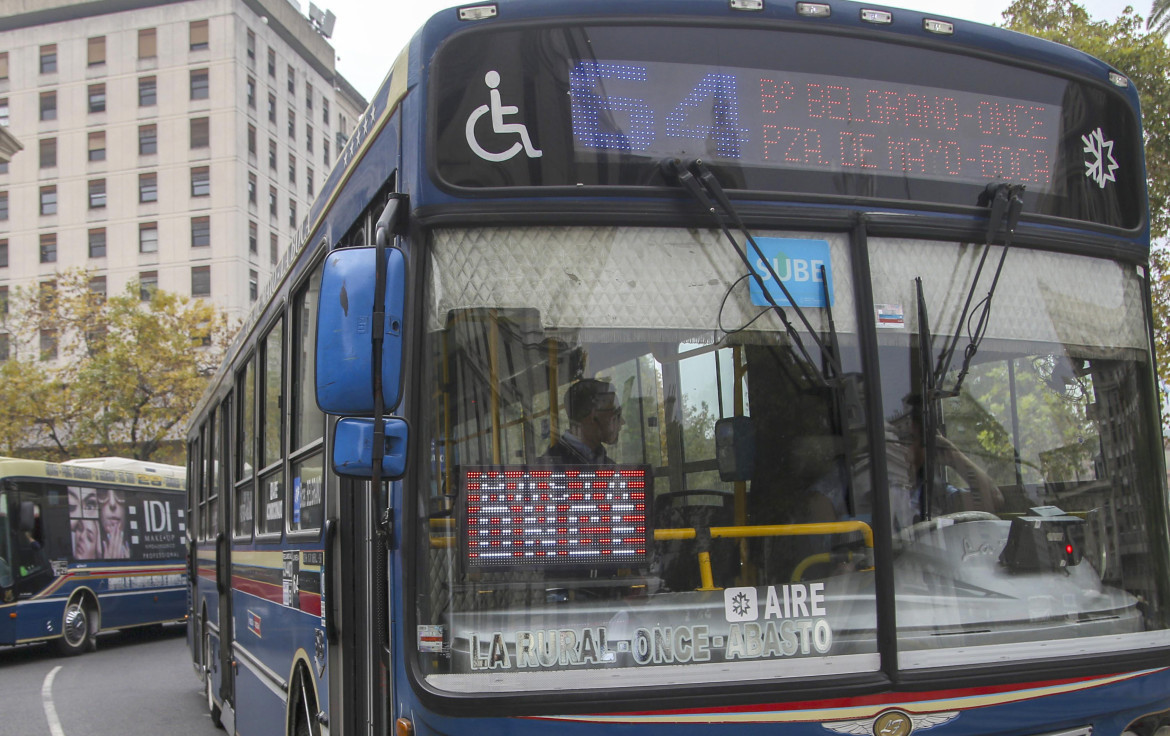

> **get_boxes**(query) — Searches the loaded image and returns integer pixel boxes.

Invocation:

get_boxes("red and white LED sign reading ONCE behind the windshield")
[460,466,651,570]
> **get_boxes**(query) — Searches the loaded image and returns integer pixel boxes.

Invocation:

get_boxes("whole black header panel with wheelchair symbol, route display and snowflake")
[427,21,1147,228]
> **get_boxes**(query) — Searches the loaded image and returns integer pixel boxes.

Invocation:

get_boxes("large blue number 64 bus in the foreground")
[188,0,1170,736]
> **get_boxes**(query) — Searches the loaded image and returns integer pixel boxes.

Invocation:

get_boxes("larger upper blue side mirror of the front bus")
[317,247,406,415]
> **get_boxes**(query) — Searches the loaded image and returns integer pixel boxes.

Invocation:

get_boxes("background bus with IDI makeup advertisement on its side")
[0,458,187,654]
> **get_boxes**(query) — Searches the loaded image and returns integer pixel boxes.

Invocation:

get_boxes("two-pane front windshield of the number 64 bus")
[414,227,1166,693]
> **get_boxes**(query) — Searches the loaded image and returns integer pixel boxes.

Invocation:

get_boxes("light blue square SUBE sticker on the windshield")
[748,238,833,308]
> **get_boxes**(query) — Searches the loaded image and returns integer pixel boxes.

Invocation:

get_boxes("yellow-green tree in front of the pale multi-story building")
[0,270,229,461]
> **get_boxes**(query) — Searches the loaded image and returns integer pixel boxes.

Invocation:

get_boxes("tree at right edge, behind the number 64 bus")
[1004,0,1170,431]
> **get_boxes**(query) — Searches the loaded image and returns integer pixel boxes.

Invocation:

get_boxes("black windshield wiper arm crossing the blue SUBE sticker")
[662,158,842,383]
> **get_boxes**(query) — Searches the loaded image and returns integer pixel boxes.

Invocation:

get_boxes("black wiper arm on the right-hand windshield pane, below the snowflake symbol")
[923,184,1024,400]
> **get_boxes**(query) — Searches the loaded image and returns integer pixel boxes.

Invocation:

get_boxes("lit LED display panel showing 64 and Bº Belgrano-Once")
[569,61,1061,192]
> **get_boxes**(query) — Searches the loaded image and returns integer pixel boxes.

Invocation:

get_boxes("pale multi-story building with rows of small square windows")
[0,0,366,357]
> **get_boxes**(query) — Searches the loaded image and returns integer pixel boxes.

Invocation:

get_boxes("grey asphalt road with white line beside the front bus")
[0,627,223,736]
